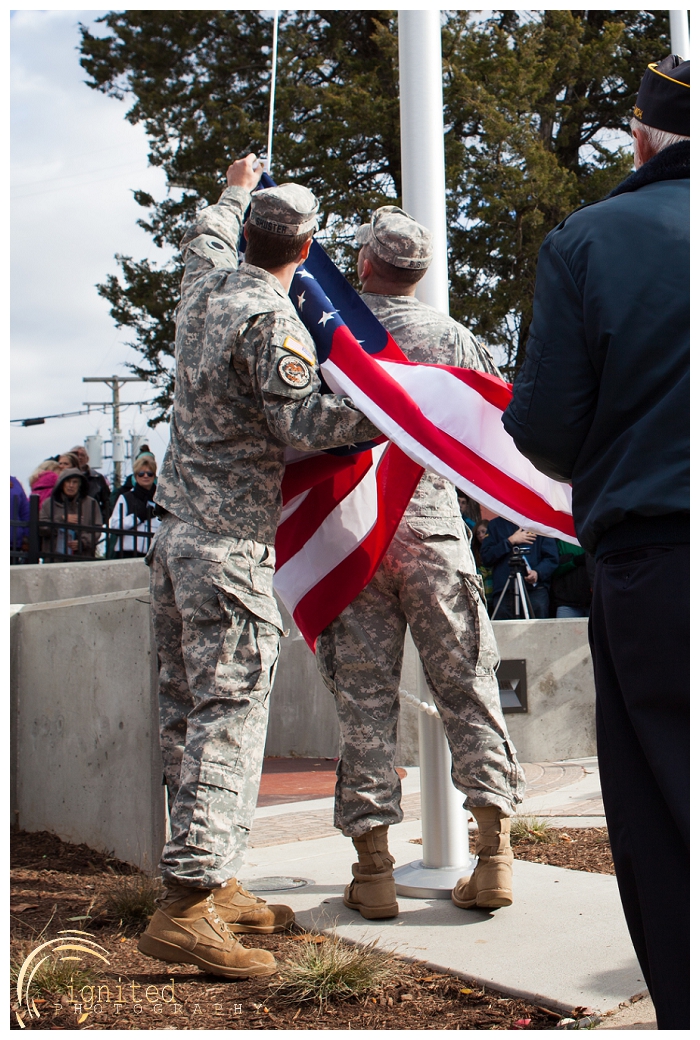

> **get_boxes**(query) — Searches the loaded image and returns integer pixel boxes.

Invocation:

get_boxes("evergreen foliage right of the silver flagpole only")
[443,10,670,378]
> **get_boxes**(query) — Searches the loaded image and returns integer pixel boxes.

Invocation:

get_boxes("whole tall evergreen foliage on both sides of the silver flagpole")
[81,10,669,421]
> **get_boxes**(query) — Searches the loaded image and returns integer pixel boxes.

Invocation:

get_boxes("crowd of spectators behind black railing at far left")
[9,444,160,563]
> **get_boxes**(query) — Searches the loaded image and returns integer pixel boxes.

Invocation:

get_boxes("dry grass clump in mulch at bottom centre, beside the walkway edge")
[275,935,396,1006]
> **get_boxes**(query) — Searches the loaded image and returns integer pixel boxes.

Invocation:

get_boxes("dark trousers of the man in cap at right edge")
[589,545,690,1030]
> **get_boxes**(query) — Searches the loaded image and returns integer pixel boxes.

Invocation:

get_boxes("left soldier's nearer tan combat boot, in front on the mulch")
[138,882,277,979]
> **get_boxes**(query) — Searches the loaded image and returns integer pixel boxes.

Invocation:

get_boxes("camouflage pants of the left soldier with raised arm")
[149,517,282,887]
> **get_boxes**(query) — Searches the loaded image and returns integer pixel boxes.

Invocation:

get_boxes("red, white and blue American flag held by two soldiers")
[248,175,576,650]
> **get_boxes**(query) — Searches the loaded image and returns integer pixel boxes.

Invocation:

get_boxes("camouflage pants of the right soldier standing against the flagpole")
[316,517,524,837]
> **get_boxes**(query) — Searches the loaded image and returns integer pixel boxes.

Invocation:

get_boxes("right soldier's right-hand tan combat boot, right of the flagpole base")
[452,805,513,910]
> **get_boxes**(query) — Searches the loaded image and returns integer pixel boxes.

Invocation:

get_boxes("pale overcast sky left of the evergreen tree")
[9,10,174,491]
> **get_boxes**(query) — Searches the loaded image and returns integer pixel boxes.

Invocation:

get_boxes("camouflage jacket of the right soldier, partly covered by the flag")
[362,292,500,517]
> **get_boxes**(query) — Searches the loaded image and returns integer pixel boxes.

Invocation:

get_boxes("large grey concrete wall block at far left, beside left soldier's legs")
[11,590,164,873]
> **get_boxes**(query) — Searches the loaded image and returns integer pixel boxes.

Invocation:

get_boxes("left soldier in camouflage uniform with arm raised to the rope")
[139,155,378,978]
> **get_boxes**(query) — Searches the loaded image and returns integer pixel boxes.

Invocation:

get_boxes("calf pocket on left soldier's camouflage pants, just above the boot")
[187,761,243,856]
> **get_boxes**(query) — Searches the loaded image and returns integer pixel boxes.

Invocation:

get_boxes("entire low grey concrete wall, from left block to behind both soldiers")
[10,561,595,872]
